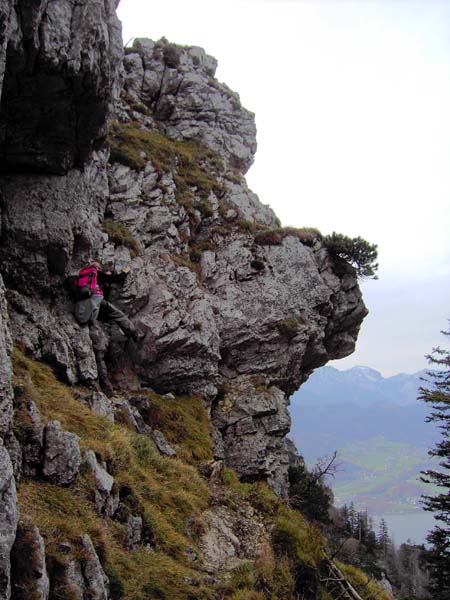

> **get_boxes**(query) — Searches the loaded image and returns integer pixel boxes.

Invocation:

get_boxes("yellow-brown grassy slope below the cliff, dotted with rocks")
[10,352,390,600]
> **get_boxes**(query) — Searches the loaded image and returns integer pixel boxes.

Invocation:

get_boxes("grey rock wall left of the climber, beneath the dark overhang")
[0,157,108,383]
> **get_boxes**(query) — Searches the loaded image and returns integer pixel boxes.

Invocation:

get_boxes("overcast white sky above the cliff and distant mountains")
[119,0,450,375]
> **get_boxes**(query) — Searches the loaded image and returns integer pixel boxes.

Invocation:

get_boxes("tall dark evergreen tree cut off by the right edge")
[419,328,450,600]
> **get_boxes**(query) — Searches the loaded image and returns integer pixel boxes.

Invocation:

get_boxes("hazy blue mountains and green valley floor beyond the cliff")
[291,367,439,513]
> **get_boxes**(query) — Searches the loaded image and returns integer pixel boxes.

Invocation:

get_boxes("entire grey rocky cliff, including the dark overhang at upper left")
[0,0,367,598]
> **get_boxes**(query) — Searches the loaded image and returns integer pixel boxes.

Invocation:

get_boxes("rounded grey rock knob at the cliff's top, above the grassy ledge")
[120,39,256,172]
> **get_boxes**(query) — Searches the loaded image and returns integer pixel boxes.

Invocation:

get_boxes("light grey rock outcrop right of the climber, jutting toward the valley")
[101,40,367,494]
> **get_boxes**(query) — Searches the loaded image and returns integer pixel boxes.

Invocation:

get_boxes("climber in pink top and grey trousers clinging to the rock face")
[74,261,143,393]
